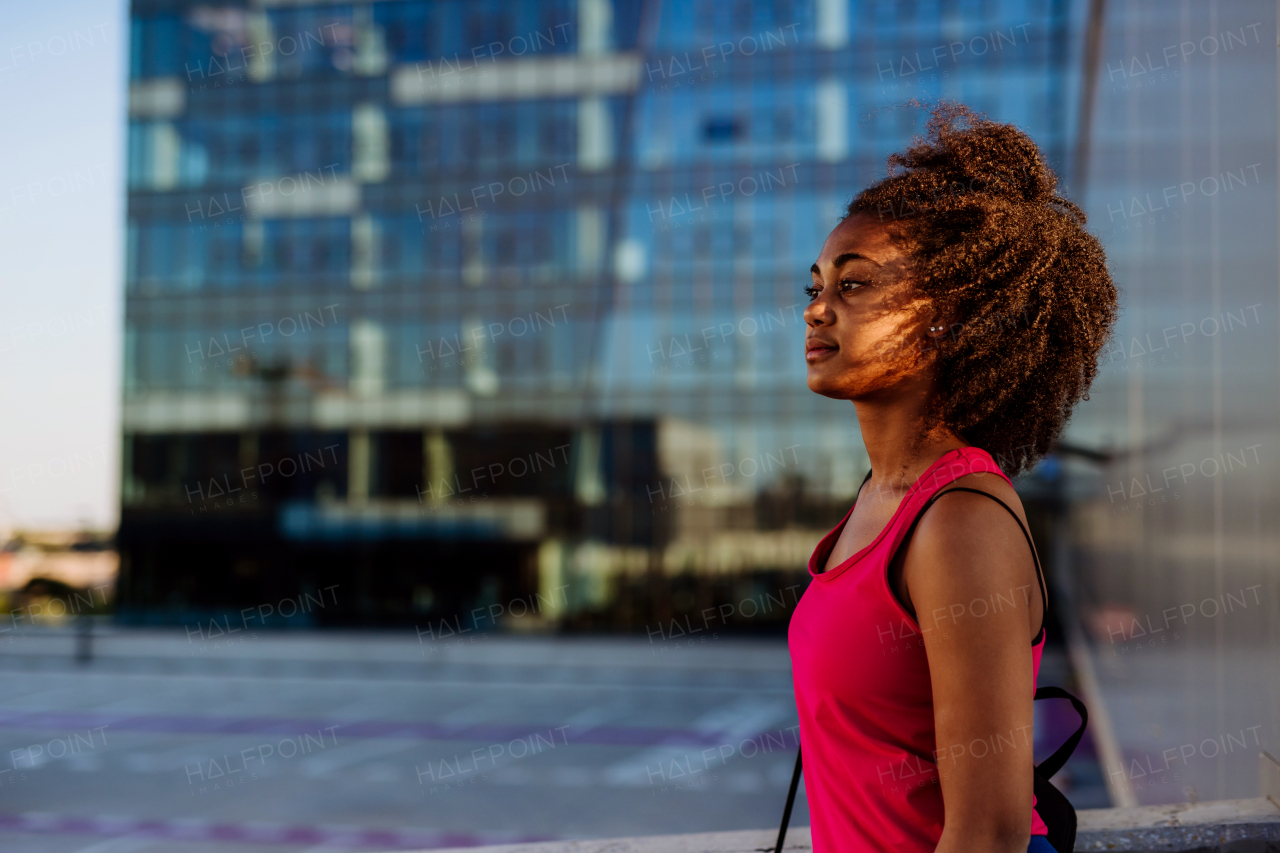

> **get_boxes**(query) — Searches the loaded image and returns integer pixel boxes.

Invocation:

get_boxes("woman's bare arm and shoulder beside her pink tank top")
[902,478,1042,853]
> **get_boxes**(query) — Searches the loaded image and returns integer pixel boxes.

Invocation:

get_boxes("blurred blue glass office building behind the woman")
[119,0,1079,630]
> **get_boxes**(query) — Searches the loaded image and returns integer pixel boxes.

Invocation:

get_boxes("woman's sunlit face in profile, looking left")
[804,214,931,400]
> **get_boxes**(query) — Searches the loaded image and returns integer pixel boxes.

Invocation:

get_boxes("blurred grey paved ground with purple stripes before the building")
[0,622,1105,853]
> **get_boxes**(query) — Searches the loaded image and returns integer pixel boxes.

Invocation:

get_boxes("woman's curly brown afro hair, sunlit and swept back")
[845,101,1117,476]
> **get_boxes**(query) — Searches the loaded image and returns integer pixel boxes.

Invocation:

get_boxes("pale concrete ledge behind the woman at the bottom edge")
[391,797,1280,853]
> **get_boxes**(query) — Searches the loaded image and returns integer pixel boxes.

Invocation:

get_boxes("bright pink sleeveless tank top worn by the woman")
[787,447,1048,853]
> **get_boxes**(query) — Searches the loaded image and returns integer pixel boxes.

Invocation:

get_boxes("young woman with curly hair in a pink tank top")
[788,104,1116,853]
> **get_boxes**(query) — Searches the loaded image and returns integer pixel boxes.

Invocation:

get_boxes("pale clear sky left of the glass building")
[0,0,128,537]
